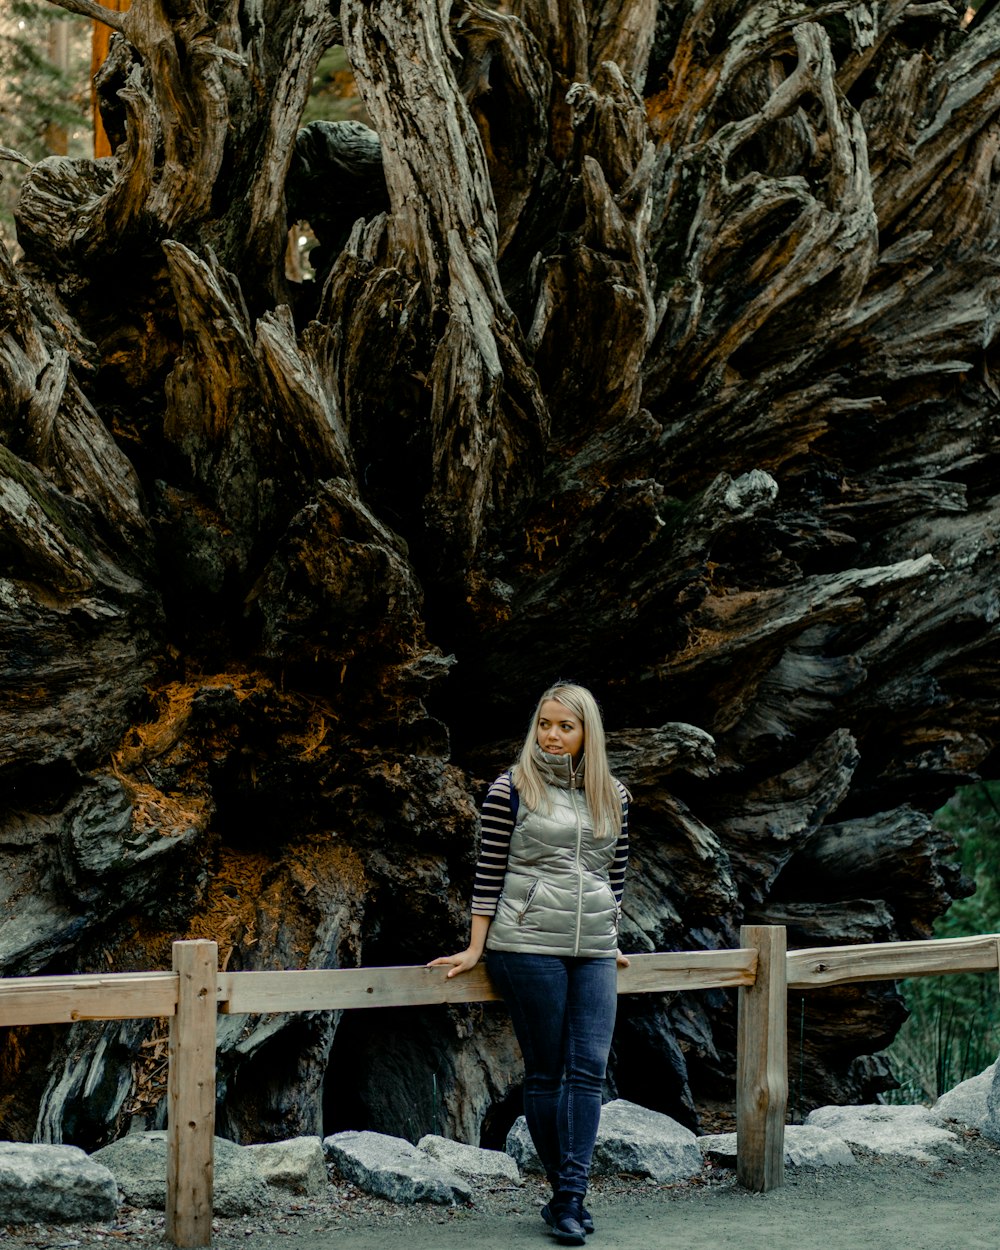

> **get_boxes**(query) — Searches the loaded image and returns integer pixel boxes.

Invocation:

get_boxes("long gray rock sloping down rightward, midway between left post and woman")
[323,1130,473,1204]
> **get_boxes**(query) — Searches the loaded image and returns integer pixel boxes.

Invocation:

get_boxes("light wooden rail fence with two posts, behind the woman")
[0,925,1000,1248]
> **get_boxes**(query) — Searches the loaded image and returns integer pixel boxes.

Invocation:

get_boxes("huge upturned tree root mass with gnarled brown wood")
[0,0,1000,1146]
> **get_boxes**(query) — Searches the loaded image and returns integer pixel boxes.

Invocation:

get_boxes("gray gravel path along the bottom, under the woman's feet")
[0,1133,1000,1250]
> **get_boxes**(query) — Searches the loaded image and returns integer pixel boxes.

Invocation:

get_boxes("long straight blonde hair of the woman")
[510,681,628,838]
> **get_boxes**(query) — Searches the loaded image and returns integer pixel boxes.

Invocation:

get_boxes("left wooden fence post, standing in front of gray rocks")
[166,941,219,1248]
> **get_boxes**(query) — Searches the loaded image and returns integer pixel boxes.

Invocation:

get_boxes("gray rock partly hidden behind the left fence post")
[91,1130,271,1215]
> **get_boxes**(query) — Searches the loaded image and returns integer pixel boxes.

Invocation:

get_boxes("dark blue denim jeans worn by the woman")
[486,950,618,1196]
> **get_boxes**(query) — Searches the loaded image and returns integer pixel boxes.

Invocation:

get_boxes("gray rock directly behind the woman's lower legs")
[506,1099,704,1184]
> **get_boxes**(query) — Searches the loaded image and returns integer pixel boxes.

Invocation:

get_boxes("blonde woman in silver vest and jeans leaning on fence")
[430,683,629,1245]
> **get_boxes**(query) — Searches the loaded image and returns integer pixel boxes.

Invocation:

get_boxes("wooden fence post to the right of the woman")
[736,925,789,1194]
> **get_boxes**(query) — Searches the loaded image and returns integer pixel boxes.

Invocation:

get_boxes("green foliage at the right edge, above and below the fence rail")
[886,781,1000,1103]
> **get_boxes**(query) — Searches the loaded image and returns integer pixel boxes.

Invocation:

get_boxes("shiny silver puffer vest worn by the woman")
[486,751,618,958]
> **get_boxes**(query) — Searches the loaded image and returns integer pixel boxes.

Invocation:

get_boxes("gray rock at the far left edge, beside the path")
[0,1141,118,1224]
